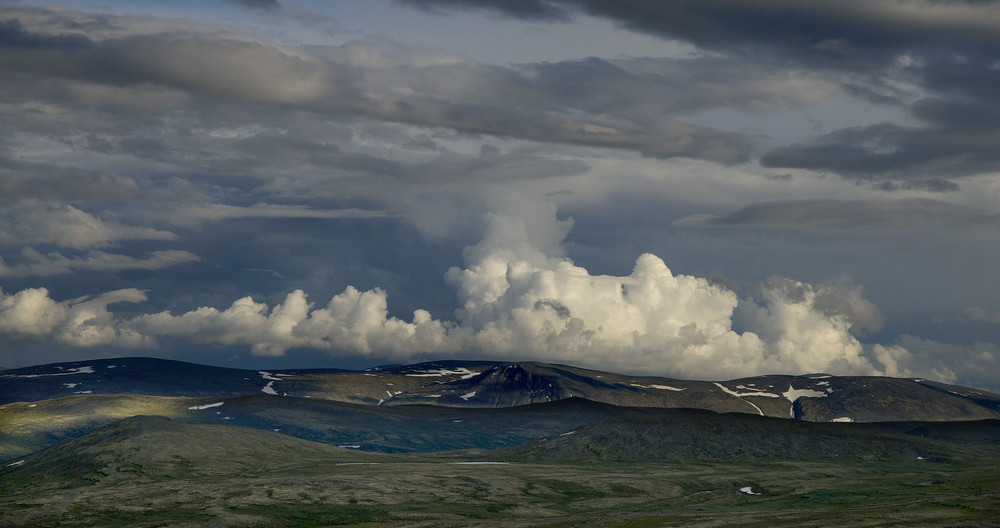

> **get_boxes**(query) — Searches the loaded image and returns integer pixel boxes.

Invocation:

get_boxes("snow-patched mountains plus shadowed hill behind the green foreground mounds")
[0,357,1000,459]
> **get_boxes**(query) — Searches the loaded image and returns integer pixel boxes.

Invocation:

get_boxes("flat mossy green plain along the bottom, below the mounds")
[0,455,1000,528]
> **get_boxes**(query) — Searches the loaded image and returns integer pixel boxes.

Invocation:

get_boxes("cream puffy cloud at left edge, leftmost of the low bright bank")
[0,288,152,348]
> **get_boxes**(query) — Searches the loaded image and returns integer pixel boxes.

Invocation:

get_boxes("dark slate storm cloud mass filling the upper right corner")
[400,0,1000,181]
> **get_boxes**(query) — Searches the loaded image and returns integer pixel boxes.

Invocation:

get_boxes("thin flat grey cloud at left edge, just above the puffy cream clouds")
[0,248,201,278]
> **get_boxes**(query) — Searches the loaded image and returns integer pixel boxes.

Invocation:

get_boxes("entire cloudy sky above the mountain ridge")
[0,0,1000,391]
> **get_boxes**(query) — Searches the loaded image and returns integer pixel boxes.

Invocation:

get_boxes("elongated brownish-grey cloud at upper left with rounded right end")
[0,11,333,102]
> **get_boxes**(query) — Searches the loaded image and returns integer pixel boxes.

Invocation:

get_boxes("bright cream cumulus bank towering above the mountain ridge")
[0,209,900,377]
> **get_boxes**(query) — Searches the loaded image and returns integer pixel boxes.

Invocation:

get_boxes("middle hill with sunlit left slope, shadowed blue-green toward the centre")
[0,394,623,460]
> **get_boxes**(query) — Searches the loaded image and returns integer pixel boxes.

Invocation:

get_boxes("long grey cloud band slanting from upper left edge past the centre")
[0,6,772,163]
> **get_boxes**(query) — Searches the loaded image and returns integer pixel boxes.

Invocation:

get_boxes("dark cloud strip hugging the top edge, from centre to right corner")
[397,0,1000,63]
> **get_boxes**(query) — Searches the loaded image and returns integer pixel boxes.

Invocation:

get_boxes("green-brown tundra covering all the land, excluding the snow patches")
[0,358,1000,527]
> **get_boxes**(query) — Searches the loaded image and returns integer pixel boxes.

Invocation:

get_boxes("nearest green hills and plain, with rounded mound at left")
[0,412,1000,528]
